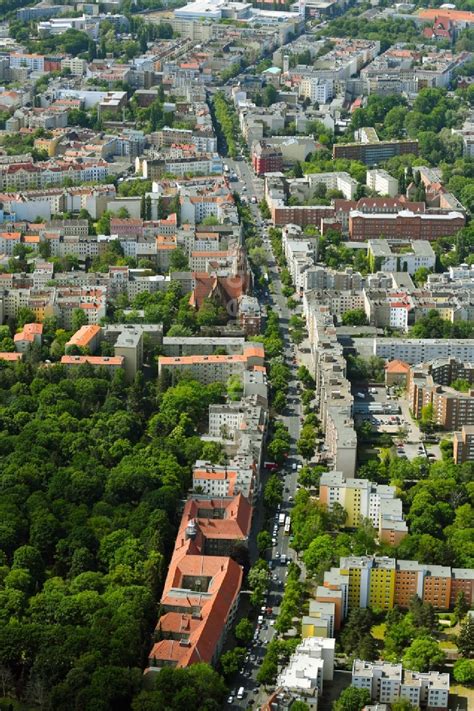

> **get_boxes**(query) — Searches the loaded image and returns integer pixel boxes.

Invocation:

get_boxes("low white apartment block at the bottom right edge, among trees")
[352,659,450,709]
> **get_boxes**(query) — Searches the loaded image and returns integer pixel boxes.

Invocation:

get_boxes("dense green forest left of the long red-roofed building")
[0,363,225,711]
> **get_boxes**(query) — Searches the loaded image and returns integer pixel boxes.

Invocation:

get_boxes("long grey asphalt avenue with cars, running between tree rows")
[229,158,302,709]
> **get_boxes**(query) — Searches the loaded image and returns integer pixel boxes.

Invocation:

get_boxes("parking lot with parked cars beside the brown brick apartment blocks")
[353,385,441,461]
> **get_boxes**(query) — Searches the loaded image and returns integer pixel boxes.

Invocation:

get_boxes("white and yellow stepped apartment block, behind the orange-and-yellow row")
[319,471,408,545]
